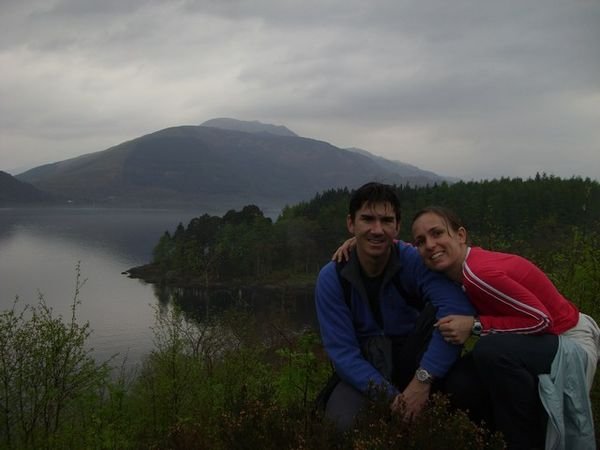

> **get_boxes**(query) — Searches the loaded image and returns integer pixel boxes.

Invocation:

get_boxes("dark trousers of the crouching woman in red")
[444,334,558,450]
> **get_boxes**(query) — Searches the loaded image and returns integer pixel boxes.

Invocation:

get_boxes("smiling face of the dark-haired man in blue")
[347,202,400,259]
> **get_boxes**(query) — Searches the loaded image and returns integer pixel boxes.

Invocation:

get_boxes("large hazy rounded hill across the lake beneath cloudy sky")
[18,119,452,211]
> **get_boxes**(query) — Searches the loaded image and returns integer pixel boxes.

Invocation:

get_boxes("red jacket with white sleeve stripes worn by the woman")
[463,247,579,335]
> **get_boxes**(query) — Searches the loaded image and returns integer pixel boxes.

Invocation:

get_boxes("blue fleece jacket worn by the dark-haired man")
[315,242,475,397]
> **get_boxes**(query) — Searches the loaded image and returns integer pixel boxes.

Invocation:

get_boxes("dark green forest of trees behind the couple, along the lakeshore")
[146,175,600,312]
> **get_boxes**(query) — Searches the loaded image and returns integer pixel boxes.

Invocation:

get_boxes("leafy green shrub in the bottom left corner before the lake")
[0,267,109,449]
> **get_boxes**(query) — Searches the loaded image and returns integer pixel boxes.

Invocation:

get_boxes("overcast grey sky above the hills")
[0,0,600,180]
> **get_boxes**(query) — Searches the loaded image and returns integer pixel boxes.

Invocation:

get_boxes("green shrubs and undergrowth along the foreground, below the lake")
[0,282,502,450]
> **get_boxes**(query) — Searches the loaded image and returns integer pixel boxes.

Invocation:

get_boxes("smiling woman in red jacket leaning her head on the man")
[336,206,600,449]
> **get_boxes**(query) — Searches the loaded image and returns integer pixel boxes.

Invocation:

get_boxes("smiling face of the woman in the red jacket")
[412,212,467,281]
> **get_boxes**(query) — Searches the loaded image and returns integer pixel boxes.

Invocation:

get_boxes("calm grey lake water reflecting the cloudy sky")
[0,208,315,366]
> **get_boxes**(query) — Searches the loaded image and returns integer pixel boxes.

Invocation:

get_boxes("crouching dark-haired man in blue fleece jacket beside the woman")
[316,183,474,430]
